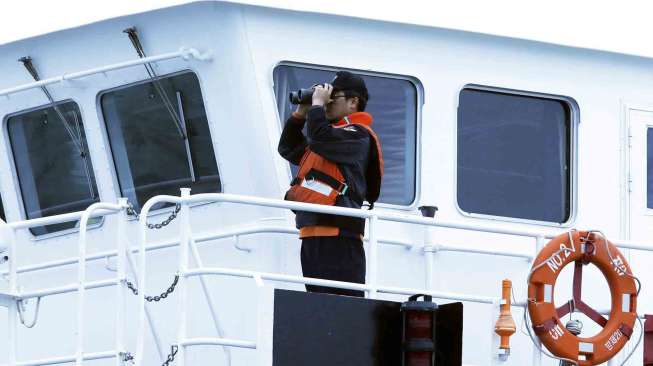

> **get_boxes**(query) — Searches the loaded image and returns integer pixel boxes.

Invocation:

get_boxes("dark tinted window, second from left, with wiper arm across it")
[101,72,222,209]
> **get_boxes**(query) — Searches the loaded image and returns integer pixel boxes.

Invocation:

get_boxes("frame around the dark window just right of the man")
[453,83,580,227]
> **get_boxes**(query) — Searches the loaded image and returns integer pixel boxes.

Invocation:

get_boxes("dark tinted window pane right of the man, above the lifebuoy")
[457,89,571,223]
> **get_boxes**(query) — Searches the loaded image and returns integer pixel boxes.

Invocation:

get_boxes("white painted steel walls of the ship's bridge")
[0,3,653,366]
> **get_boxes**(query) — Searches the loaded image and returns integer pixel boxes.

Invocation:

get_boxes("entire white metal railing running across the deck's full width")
[5,189,653,366]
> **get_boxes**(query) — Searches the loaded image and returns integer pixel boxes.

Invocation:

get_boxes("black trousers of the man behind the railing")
[301,236,365,297]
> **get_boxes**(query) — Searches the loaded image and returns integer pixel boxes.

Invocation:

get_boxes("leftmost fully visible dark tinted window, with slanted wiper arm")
[7,101,98,235]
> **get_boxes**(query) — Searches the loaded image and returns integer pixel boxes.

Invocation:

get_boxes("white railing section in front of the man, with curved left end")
[136,189,653,366]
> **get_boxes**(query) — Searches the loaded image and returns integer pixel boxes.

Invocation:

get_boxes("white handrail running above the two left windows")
[0,47,213,96]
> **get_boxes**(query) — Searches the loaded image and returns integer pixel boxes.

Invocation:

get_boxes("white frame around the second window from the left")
[95,68,222,217]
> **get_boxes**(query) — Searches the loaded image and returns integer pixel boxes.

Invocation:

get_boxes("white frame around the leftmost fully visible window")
[2,97,104,241]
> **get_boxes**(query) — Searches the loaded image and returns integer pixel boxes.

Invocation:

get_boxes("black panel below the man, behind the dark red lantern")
[273,290,462,366]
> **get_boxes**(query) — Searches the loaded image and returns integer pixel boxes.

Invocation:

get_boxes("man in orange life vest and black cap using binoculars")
[278,71,383,297]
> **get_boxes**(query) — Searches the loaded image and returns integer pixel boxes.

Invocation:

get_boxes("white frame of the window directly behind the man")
[269,60,424,211]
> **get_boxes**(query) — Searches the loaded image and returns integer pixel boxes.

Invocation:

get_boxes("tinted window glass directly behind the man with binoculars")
[274,65,417,205]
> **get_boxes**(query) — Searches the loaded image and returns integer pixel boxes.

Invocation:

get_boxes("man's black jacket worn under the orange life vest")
[278,106,371,234]
